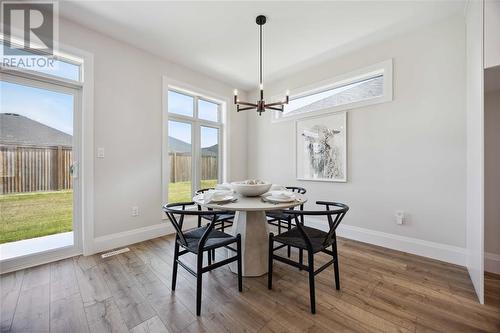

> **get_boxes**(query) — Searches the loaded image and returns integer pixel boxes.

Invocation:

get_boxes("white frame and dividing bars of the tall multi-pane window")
[162,81,227,205]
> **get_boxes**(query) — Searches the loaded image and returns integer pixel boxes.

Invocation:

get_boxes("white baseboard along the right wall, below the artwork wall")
[306,219,466,266]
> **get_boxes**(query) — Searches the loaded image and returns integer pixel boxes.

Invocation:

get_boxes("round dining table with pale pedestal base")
[193,193,307,277]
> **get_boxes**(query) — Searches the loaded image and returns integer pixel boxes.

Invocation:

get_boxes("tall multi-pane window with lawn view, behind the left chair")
[166,88,223,202]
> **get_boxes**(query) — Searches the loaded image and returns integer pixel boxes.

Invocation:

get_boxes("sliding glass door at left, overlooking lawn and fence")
[0,75,80,260]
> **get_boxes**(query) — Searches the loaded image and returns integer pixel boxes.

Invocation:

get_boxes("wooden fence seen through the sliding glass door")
[0,145,73,194]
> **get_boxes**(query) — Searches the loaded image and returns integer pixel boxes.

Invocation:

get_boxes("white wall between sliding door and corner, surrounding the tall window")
[56,20,246,246]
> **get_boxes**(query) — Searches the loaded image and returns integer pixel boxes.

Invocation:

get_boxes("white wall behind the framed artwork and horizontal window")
[248,15,466,249]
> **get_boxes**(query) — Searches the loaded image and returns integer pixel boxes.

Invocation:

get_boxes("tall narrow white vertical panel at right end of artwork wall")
[465,0,484,304]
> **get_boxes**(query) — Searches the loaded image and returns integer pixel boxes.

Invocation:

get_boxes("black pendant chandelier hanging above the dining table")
[234,15,289,116]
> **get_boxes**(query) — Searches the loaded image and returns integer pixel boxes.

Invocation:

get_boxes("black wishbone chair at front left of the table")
[163,202,243,316]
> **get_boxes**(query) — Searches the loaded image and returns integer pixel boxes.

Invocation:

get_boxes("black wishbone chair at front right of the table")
[267,201,349,313]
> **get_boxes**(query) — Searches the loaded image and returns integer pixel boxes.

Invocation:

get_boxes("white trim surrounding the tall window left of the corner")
[161,76,229,213]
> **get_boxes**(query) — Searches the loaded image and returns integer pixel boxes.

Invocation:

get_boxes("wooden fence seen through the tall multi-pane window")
[168,153,219,183]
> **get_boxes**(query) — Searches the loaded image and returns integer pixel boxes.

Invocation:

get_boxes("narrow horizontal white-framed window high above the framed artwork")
[275,60,392,119]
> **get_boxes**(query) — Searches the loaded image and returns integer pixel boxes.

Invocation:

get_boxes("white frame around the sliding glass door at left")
[0,43,95,274]
